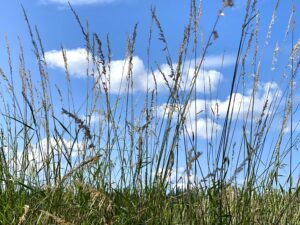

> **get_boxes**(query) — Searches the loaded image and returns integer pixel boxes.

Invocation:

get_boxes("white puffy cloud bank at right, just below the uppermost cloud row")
[157,82,281,139]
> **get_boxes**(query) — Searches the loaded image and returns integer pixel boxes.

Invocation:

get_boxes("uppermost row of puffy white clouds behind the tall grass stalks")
[45,48,229,93]
